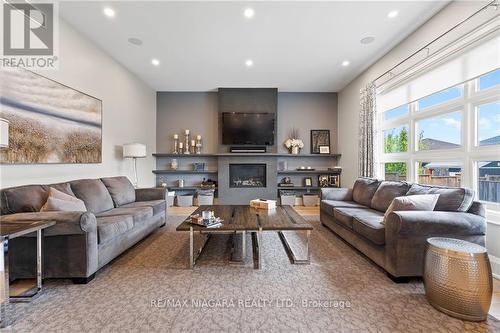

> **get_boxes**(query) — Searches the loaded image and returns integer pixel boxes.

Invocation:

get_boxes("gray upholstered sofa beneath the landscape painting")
[0,177,166,283]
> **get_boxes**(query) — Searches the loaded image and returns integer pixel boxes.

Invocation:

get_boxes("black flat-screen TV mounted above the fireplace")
[222,112,275,146]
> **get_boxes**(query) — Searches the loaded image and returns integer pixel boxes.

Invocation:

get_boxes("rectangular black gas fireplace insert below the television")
[229,163,266,188]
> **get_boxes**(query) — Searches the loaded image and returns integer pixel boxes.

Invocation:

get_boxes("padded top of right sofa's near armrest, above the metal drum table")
[386,211,486,238]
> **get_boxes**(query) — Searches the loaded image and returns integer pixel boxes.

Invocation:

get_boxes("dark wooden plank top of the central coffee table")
[176,205,313,231]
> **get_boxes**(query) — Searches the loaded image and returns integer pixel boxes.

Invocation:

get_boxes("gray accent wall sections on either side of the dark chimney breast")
[156,92,336,154]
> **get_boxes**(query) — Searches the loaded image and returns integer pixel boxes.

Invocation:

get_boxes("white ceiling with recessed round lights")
[59,1,447,92]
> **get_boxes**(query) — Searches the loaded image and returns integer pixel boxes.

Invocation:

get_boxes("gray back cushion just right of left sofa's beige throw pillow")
[71,179,114,214]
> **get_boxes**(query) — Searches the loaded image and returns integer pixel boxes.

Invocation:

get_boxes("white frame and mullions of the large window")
[377,74,500,217]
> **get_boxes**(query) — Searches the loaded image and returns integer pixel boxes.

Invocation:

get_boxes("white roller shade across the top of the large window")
[377,17,500,112]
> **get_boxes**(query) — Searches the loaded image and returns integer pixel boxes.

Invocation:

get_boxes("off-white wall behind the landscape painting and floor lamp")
[0,20,156,188]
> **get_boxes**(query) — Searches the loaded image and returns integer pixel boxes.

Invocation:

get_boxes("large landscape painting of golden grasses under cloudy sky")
[0,70,102,164]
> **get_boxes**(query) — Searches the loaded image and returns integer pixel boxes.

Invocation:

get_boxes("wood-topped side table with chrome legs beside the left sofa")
[0,221,55,327]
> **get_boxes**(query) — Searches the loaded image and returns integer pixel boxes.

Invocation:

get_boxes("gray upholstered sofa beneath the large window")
[320,178,486,282]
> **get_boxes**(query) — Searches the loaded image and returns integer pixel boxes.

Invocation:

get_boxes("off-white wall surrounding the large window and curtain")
[338,1,500,276]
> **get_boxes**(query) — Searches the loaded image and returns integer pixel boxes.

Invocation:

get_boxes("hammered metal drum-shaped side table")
[424,237,493,321]
